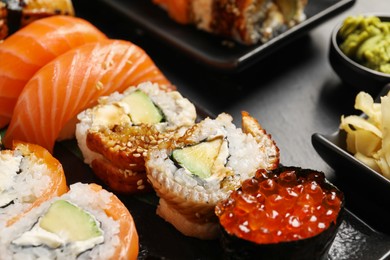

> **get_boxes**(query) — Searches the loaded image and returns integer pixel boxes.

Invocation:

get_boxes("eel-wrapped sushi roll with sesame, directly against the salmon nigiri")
[76,82,196,193]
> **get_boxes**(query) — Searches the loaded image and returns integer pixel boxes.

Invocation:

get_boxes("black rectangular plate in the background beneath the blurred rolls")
[95,0,355,71]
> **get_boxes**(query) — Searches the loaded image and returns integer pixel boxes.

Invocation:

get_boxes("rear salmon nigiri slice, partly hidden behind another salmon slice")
[0,15,107,128]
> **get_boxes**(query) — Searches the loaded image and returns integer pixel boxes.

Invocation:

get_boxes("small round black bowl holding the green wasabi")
[329,14,390,94]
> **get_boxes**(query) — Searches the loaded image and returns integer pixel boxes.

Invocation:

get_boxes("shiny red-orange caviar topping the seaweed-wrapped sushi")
[215,168,342,244]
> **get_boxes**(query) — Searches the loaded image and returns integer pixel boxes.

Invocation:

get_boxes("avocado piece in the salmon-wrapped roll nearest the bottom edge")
[39,200,103,242]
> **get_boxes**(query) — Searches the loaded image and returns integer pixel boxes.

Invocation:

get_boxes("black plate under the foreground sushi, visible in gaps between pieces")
[50,99,390,260]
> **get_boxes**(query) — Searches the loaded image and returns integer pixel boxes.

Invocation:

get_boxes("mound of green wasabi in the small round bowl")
[338,16,390,74]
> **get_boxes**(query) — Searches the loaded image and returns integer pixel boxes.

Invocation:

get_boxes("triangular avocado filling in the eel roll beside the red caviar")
[172,138,223,179]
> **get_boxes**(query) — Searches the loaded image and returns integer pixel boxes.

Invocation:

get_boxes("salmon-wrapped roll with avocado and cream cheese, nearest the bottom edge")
[0,183,139,260]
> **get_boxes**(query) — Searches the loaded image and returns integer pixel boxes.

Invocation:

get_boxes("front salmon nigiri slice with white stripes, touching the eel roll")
[3,40,174,151]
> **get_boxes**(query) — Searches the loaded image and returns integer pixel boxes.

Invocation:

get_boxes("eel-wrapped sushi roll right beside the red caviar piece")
[145,113,279,239]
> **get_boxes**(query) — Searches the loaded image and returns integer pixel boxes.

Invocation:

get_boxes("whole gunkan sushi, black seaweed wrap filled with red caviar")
[215,167,344,259]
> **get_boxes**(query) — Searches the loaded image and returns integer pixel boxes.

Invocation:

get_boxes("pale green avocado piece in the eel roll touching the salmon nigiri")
[122,90,164,125]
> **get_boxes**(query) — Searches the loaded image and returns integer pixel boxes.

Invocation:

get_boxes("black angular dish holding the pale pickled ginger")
[312,84,390,242]
